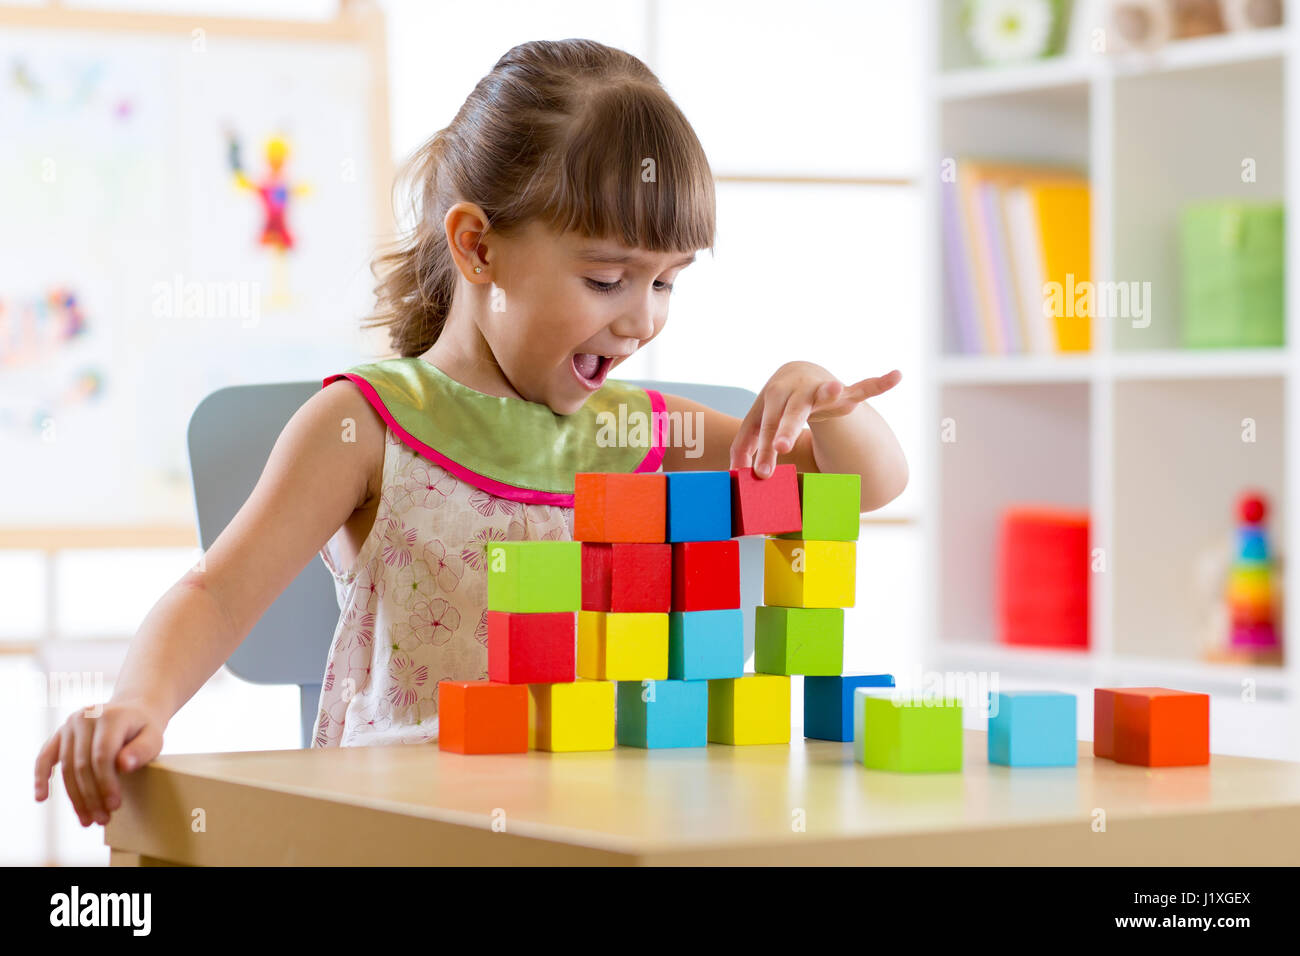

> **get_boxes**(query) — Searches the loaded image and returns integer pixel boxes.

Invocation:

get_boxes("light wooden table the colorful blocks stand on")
[105,731,1300,866]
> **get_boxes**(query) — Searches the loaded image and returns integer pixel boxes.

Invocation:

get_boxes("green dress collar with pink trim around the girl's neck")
[322,358,666,507]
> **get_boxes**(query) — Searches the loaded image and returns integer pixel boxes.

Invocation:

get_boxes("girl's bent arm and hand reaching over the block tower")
[663,362,907,511]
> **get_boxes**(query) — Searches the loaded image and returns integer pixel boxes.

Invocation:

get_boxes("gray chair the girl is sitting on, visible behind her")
[187,380,763,747]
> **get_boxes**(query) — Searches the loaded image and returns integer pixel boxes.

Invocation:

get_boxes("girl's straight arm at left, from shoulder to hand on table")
[36,382,385,826]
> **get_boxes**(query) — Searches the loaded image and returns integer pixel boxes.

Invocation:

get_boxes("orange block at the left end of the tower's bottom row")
[438,680,528,753]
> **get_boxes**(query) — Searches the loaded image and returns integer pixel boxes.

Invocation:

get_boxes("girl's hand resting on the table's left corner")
[36,701,166,826]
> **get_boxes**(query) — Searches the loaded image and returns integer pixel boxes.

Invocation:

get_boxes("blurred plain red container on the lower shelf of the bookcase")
[997,507,1089,648]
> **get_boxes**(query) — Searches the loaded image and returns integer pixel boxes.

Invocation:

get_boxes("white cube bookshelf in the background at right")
[918,0,1300,706]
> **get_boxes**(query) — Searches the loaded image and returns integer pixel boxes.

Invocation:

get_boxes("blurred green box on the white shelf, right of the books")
[1179,200,1286,349]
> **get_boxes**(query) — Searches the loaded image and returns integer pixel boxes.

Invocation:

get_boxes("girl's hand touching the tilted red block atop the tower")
[731,362,902,477]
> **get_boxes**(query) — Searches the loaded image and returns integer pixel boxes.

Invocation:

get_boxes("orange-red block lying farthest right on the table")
[1113,687,1210,767]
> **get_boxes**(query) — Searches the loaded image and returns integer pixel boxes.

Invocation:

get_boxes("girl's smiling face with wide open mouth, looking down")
[478,222,696,415]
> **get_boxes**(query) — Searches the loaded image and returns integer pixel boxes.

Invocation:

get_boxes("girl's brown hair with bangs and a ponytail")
[364,39,714,356]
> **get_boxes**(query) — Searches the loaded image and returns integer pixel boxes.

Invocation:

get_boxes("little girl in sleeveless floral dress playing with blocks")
[36,40,907,826]
